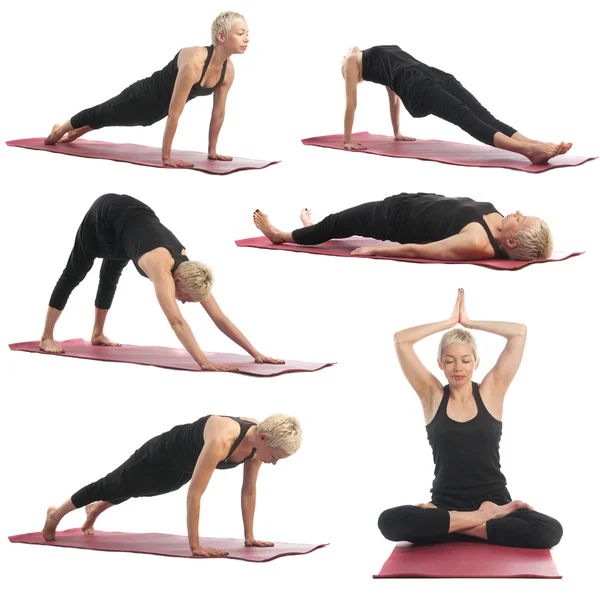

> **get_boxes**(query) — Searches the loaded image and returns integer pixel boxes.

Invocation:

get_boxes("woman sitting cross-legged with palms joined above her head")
[379,290,562,548]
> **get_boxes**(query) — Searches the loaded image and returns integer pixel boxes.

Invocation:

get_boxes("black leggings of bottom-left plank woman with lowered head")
[71,438,192,508]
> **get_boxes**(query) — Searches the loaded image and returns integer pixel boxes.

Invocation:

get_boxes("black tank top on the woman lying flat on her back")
[381,192,506,258]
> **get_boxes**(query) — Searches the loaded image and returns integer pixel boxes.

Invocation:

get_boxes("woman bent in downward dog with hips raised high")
[40,194,284,371]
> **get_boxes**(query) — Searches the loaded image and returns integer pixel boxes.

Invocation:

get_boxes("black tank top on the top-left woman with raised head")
[129,45,227,109]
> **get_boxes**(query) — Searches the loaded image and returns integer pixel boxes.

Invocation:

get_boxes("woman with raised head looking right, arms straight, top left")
[46,12,249,168]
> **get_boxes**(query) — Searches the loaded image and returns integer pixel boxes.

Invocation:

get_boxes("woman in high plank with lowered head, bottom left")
[42,414,302,557]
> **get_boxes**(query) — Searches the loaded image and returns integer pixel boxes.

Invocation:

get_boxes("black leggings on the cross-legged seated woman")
[378,505,563,548]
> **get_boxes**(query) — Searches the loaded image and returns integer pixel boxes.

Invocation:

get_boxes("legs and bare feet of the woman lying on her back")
[254,202,385,246]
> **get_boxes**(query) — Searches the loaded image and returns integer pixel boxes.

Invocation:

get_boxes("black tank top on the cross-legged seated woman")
[426,382,506,496]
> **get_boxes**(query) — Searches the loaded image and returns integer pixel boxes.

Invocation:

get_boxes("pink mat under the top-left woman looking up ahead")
[6,138,279,175]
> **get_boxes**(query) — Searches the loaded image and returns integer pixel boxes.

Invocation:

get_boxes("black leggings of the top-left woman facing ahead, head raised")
[71,88,169,129]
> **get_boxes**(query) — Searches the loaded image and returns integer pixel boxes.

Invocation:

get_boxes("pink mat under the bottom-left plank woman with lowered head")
[8,529,327,562]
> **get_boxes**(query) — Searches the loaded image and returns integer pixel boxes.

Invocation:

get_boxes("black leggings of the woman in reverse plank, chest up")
[410,74,517,146]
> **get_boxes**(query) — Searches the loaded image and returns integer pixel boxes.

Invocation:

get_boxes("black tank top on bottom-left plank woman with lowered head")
[162,415,256,473]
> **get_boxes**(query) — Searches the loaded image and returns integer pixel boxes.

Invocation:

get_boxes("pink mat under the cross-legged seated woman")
[373,542,562,579]
